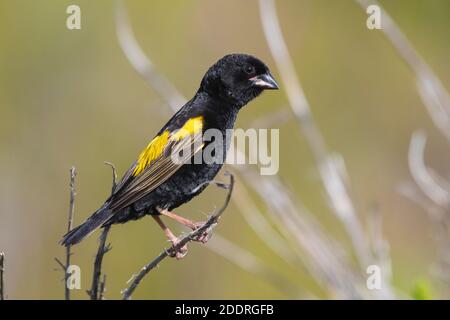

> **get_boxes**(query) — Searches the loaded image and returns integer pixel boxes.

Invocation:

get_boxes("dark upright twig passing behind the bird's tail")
[88,161,117,300]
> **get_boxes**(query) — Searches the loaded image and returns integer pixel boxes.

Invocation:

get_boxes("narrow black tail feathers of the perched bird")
[60,203,112,247]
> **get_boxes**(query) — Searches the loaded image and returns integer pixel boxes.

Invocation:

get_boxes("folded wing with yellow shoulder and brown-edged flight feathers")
[110,117,203,211]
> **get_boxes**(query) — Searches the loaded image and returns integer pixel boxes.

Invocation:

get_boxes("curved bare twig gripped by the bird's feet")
[122,172,234,300]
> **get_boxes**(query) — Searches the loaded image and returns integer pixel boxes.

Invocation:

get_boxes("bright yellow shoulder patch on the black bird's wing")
[133,116,203,176]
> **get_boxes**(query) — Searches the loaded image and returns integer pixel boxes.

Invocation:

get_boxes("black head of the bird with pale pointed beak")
[200,54,278,108]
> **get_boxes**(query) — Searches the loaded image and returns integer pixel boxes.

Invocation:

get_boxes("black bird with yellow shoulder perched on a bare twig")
[61,53,279,259]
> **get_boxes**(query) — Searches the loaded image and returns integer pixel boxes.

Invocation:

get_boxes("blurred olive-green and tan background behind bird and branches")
[0,0,450,299]
